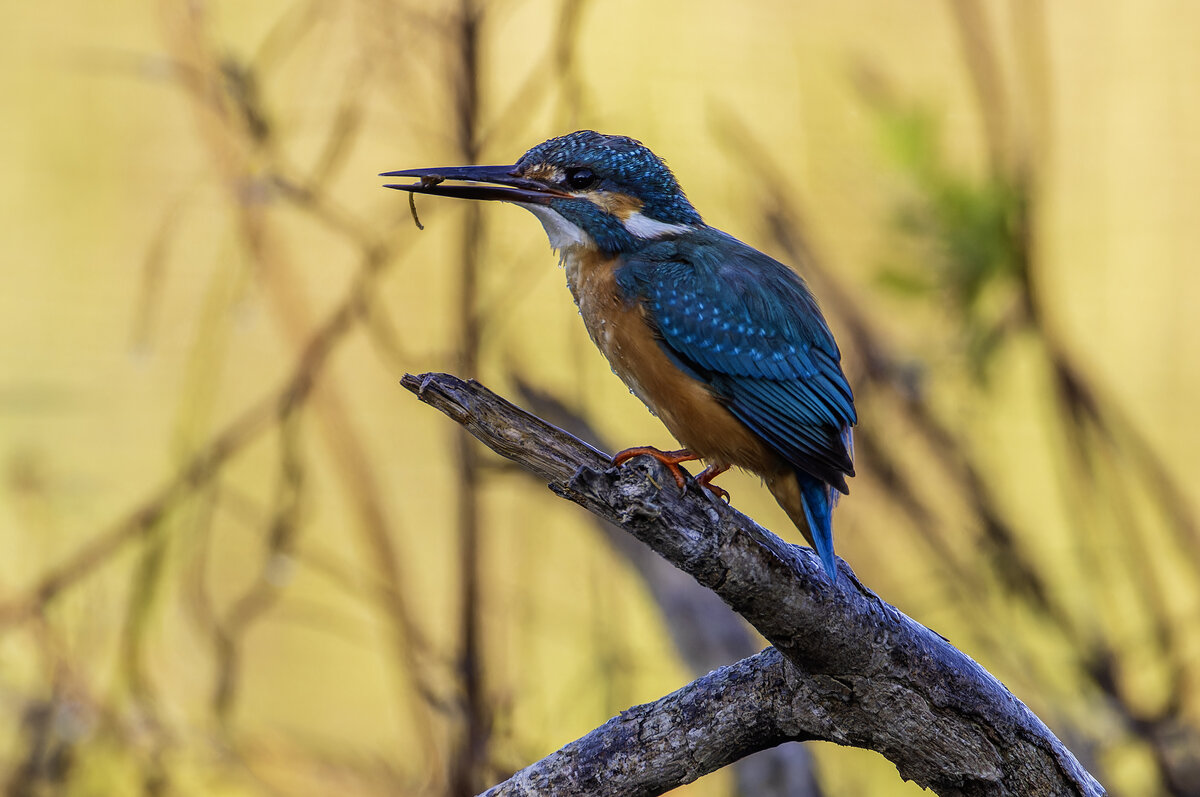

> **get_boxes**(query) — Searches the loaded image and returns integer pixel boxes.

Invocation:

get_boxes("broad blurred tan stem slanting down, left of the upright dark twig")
[154,0,442,778]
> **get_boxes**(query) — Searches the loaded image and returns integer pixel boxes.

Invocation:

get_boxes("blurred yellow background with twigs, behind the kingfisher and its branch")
[0,0,1200,795]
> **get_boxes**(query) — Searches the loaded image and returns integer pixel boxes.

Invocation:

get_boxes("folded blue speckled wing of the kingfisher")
[617,228,858,492]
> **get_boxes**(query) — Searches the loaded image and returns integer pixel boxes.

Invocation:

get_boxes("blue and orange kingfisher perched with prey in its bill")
[380,130,858,581]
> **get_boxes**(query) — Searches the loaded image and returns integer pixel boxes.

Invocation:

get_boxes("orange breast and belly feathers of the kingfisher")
[565,253,785,475]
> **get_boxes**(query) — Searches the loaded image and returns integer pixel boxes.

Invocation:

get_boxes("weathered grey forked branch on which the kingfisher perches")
[402,373,1104,796]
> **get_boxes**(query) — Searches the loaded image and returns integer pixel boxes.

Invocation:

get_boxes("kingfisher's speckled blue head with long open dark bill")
[382,130,703,253]
